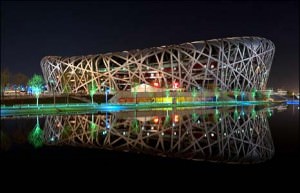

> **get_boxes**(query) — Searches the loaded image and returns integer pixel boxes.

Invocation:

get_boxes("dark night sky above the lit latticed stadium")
[1,1,299,91]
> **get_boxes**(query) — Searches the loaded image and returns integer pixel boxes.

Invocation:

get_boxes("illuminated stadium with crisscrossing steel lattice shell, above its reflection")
[41,37,275,102]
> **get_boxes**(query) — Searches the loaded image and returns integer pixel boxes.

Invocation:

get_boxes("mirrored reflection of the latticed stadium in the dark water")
[43,107,274,164]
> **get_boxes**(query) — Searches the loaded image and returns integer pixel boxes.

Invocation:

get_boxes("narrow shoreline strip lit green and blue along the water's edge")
[1,101,285,117]
